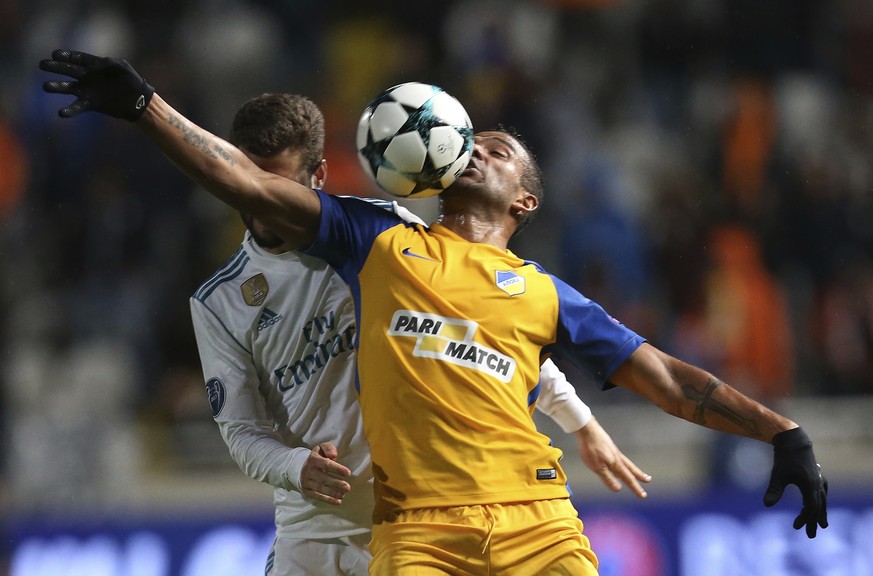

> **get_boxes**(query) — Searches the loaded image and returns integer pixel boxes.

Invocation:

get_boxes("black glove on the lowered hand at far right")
[764,428,828,538]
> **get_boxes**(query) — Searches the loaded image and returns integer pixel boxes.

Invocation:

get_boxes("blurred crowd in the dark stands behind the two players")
[0,0,873,505]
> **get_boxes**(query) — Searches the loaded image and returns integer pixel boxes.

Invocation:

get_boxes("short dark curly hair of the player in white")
[228,93,325,174]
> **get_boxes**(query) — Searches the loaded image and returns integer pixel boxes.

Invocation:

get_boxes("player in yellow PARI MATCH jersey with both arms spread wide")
[41,51,827,576]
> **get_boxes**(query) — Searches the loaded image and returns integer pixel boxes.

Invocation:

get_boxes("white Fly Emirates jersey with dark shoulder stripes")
[190,197,590,539]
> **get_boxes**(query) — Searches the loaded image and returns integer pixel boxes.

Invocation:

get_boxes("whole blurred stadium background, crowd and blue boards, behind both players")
[0,0,873,576]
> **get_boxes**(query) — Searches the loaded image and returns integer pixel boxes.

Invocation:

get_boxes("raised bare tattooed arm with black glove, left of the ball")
[40,50,321,246]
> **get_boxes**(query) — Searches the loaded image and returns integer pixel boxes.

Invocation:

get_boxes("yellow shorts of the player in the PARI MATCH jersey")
[370,499,597,576]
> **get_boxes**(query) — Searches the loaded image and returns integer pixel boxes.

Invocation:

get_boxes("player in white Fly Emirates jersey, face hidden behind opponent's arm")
[191,94,649,576]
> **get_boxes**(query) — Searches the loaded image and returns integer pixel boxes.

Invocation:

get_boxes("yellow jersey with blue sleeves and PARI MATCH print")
[309,194,643,522]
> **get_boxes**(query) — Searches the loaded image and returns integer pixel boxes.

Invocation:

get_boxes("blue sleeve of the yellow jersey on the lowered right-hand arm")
[536,274,645,390]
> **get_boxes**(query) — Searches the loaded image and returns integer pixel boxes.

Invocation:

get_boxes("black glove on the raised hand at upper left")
[39,50,155,122]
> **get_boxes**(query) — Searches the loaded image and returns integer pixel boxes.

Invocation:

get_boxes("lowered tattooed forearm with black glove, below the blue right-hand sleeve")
[610,344,828,538]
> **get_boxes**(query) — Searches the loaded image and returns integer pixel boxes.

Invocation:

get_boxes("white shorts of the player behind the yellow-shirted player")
[264,533,372,576]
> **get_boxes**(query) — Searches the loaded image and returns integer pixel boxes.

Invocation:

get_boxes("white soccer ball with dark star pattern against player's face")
[357,82,473,198]
